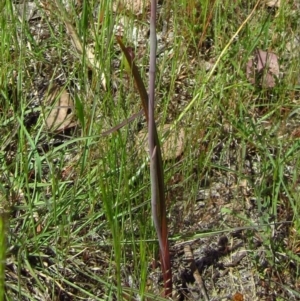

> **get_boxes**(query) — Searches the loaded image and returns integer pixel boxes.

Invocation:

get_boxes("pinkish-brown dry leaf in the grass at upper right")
[246,49,279,88]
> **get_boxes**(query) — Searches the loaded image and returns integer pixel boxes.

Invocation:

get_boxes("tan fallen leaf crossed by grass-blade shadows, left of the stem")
[45,87,76,132]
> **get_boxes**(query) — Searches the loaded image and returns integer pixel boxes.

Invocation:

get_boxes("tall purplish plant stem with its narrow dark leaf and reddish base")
[117,30,172,297]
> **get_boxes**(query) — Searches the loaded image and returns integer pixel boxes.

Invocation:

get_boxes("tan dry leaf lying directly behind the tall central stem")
[136,124,185,160]
